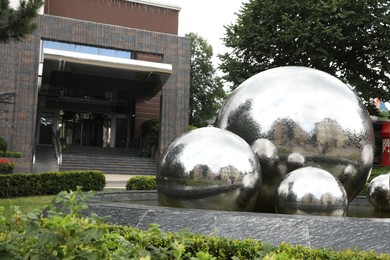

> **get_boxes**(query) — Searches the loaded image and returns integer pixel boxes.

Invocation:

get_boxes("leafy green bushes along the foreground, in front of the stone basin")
[0,187,390,260]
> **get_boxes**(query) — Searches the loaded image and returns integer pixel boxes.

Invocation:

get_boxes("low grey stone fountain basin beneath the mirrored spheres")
[88,191,390,254]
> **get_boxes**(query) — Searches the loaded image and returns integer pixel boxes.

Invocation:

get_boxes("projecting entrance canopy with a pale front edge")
[43,48,172,100]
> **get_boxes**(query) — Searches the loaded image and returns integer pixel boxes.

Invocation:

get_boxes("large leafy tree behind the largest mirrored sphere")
[220,0,390,110]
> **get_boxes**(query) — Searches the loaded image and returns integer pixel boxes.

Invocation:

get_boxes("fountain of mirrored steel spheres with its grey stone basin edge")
[90,67,390,253]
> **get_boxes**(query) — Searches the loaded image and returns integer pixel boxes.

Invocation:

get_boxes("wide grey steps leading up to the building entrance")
[60,146,157,176]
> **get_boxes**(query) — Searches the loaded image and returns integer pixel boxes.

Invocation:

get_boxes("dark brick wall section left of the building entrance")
[0,32,39,172]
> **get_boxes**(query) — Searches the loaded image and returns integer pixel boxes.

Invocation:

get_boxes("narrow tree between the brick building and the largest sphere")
[186,33,225,127]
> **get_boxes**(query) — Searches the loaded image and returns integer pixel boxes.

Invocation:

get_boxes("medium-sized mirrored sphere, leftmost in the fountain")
[157,127,261,211]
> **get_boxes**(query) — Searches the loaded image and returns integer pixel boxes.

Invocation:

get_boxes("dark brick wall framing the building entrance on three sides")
[0,15,190,172]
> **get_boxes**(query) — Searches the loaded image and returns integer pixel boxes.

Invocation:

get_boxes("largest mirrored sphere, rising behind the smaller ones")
[216,66,374,211]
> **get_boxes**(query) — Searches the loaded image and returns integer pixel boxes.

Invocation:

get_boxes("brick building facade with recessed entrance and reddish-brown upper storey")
[0,0,190,172]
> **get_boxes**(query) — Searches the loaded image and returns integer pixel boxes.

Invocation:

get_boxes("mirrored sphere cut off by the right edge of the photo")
[367,173,390,211]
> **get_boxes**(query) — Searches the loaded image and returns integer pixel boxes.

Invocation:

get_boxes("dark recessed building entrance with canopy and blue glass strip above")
[37,40,172,148]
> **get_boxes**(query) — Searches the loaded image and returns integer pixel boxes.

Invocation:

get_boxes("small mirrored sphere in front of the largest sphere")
[275,167,348,216]
